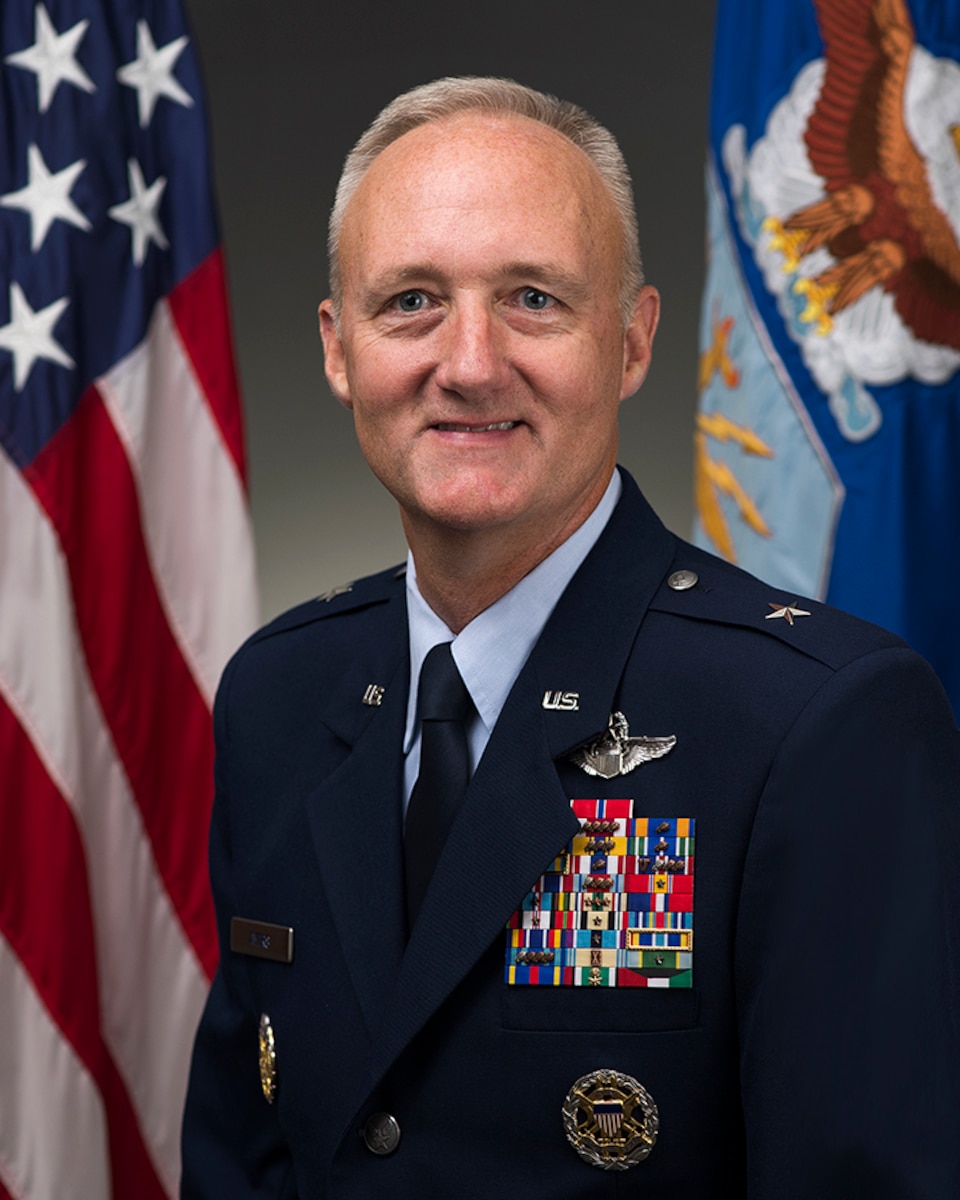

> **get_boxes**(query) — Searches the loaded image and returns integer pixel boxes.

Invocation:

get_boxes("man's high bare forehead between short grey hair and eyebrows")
[340,113,619,280]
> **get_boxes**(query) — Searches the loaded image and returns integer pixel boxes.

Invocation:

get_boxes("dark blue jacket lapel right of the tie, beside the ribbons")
[373,476,673,1076]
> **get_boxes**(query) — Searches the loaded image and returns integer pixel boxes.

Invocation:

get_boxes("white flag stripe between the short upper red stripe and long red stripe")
[96,301,257,704]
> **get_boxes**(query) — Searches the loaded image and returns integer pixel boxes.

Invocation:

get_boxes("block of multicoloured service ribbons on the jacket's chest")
[505,799,695,988]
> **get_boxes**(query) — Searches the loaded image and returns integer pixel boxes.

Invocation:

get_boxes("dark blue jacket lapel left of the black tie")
[307,595,409,1030]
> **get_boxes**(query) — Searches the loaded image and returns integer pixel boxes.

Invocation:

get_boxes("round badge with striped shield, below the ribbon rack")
[563,1070,660,1171]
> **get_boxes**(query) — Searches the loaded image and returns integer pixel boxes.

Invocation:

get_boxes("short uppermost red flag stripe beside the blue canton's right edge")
[167,248,247,487]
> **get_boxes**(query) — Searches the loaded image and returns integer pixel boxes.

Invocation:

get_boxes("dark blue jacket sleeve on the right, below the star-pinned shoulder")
[736,648,960,1200]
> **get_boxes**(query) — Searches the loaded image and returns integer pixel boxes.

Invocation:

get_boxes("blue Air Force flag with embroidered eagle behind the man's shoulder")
[696,0,960,713]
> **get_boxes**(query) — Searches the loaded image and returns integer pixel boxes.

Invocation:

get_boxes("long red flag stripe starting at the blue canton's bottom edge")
[24,388,217,977]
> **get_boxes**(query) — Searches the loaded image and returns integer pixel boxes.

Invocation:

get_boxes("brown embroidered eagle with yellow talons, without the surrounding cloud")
[781,0,960,350]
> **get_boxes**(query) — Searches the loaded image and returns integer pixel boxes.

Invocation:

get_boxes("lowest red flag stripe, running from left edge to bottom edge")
[0,698,166,1200]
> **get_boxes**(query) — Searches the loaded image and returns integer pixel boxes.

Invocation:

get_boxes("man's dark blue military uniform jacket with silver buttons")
[182,478,960,1200]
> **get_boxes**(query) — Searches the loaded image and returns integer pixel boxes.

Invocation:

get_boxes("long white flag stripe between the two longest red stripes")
[0,454,206,1195]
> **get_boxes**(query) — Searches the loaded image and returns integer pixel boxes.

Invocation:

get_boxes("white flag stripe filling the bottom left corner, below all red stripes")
[0,937,110,1200]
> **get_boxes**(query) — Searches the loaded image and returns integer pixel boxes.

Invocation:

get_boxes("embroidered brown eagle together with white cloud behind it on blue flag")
[721,0,960,442]
